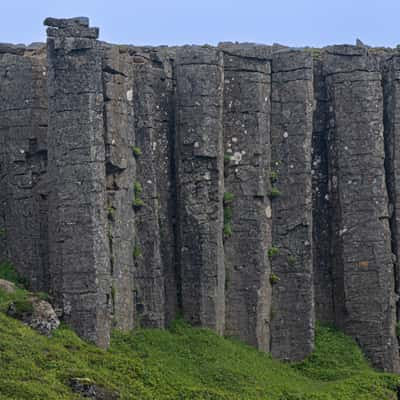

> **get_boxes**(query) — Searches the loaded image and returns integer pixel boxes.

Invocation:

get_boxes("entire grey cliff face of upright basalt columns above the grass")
[0,17,400,372]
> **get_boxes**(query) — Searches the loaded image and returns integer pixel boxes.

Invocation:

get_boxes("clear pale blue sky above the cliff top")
[0,0,400,47]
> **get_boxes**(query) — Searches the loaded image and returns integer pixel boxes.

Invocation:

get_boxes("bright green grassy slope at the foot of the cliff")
[0,282,400,400]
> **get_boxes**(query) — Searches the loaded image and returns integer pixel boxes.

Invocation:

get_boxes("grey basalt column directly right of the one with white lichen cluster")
[269,51,314,360]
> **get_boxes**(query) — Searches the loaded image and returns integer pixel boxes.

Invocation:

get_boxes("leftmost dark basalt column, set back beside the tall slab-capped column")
[0,44,49,290]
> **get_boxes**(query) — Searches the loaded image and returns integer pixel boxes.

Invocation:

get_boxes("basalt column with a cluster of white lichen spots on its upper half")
[224,48,271,351]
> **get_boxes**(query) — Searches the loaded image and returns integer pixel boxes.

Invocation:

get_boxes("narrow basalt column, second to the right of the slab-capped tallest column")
[131,48,177,328]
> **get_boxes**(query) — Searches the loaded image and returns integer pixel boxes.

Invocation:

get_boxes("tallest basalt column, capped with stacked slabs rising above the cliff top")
[45,18,111,346]
